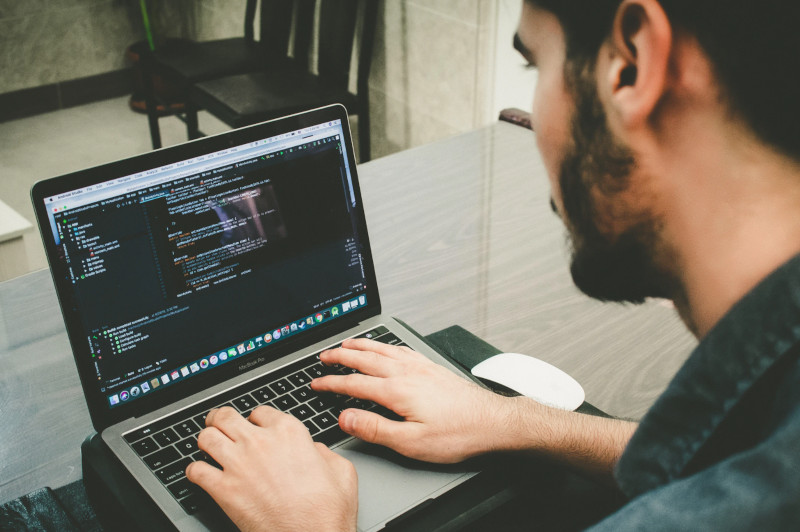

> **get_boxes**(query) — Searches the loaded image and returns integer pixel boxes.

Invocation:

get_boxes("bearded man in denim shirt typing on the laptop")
[187,0,800,530]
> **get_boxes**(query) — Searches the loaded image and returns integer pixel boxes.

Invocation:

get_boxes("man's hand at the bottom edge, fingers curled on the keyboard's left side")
[186,406,358,531]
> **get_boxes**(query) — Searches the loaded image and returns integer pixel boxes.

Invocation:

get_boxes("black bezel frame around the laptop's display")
[31,104,381,432]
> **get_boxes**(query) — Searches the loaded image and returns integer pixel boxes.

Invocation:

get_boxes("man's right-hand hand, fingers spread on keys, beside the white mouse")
[311,339,510,463]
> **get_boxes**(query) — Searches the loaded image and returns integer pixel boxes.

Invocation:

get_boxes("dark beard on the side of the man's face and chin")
[559,69,678,303]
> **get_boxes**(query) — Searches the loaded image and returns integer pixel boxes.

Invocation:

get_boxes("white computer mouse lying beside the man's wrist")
[472,353,586,410]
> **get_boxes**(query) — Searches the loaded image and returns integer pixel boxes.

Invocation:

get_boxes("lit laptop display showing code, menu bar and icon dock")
[36,112,370,420]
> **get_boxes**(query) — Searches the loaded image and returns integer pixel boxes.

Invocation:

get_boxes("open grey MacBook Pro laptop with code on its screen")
[31,105,476,531]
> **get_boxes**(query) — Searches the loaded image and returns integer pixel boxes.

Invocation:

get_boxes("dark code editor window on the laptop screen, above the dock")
[56,142,364,392]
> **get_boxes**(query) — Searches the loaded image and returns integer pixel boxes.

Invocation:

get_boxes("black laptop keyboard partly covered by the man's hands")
[123,325,405,514]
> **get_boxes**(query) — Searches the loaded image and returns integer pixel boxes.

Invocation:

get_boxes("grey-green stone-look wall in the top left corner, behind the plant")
[0,0,245,94]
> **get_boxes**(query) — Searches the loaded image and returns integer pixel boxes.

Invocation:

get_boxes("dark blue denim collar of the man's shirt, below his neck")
[615,251,800,497]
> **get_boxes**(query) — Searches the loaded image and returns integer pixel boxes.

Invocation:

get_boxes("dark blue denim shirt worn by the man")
[592,255,800,531]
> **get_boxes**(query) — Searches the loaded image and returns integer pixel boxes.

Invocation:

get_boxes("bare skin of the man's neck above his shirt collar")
[668,125,800,337]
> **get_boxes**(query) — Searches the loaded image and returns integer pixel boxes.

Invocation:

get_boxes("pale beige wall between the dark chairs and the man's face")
[369,0,496,157]
